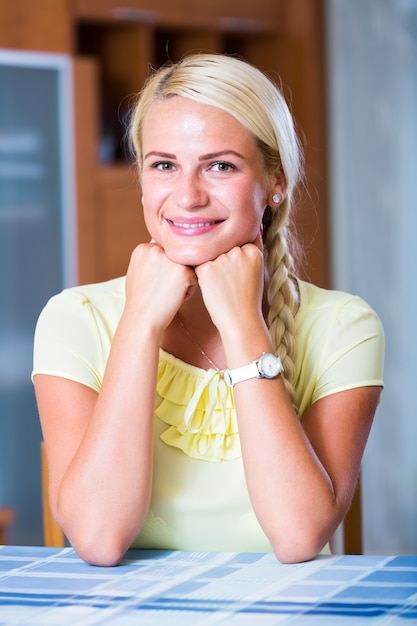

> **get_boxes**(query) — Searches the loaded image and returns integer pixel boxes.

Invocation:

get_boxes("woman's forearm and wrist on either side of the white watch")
[225,324,339,560]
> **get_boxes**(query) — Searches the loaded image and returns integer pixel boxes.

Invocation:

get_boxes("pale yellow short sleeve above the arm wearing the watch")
[294,281,385,417]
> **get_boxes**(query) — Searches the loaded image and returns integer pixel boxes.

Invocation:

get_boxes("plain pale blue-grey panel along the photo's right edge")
[327,0,417,554]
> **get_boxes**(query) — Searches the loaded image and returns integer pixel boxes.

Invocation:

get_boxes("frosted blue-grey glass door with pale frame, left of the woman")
[0,50,76,543]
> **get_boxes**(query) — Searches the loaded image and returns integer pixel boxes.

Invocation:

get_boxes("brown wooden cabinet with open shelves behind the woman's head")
[0,0,328,286]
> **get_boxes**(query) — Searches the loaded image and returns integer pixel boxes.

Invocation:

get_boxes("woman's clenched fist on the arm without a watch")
[125,241,197,330]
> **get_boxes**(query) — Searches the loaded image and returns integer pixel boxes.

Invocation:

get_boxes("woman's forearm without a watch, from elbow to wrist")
[57,317,160,561]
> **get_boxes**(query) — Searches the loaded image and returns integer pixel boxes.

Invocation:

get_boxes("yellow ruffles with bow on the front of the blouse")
[155,351,242,461]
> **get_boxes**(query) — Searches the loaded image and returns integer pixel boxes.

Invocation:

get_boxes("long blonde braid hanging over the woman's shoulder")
[265,197,299,398]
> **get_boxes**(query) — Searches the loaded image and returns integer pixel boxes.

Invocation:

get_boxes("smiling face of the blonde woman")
[141,96,279,266]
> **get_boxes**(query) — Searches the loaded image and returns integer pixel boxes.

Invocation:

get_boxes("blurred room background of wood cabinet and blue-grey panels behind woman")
[0,0,417,554]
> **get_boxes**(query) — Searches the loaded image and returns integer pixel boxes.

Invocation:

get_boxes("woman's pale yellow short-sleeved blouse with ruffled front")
[32,278,384,552]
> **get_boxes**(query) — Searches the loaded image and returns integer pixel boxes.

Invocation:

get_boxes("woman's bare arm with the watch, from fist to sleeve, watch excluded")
[196,245,380,562]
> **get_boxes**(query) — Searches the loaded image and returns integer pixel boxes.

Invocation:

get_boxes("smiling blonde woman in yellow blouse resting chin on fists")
[33,55,383,565]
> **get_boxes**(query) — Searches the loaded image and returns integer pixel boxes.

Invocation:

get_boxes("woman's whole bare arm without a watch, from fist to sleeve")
[35,244,195,565]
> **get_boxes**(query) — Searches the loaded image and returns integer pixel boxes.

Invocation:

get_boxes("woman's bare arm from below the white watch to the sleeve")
[235,381,380,562]
